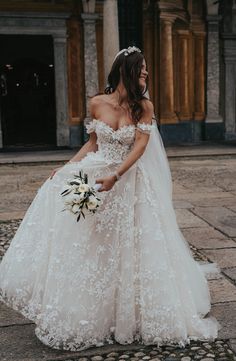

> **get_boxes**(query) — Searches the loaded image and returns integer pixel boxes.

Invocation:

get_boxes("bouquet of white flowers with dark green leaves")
[61,171,101,222]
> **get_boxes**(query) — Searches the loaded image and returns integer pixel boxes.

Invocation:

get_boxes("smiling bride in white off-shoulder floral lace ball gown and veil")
[0,47,218,351]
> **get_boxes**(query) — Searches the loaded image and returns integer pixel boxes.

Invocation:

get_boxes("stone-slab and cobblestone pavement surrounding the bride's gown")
[0,157,236,361]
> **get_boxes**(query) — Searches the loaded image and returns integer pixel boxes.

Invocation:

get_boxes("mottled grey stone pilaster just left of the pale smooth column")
[81,13,98,123]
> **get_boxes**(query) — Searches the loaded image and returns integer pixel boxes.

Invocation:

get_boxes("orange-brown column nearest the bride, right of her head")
[160,15,177,124]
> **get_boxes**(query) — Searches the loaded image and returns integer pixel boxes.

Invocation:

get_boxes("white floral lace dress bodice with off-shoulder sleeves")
[86,119,152,163]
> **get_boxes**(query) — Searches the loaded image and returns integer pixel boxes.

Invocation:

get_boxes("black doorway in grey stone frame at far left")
[0,35,56,148]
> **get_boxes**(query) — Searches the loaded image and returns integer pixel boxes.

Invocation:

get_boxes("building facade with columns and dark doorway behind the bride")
[0,0,236,149]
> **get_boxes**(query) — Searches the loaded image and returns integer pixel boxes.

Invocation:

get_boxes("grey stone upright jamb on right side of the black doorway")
[53,36,70,146]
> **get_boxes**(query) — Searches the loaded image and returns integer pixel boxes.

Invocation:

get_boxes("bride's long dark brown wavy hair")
[97,51,148,124]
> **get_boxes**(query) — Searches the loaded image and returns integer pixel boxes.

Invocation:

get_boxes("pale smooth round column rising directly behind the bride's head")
[103,0,119,84]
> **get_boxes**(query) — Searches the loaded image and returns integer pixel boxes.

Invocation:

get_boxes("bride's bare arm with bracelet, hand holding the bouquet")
[96,100,153,191]
